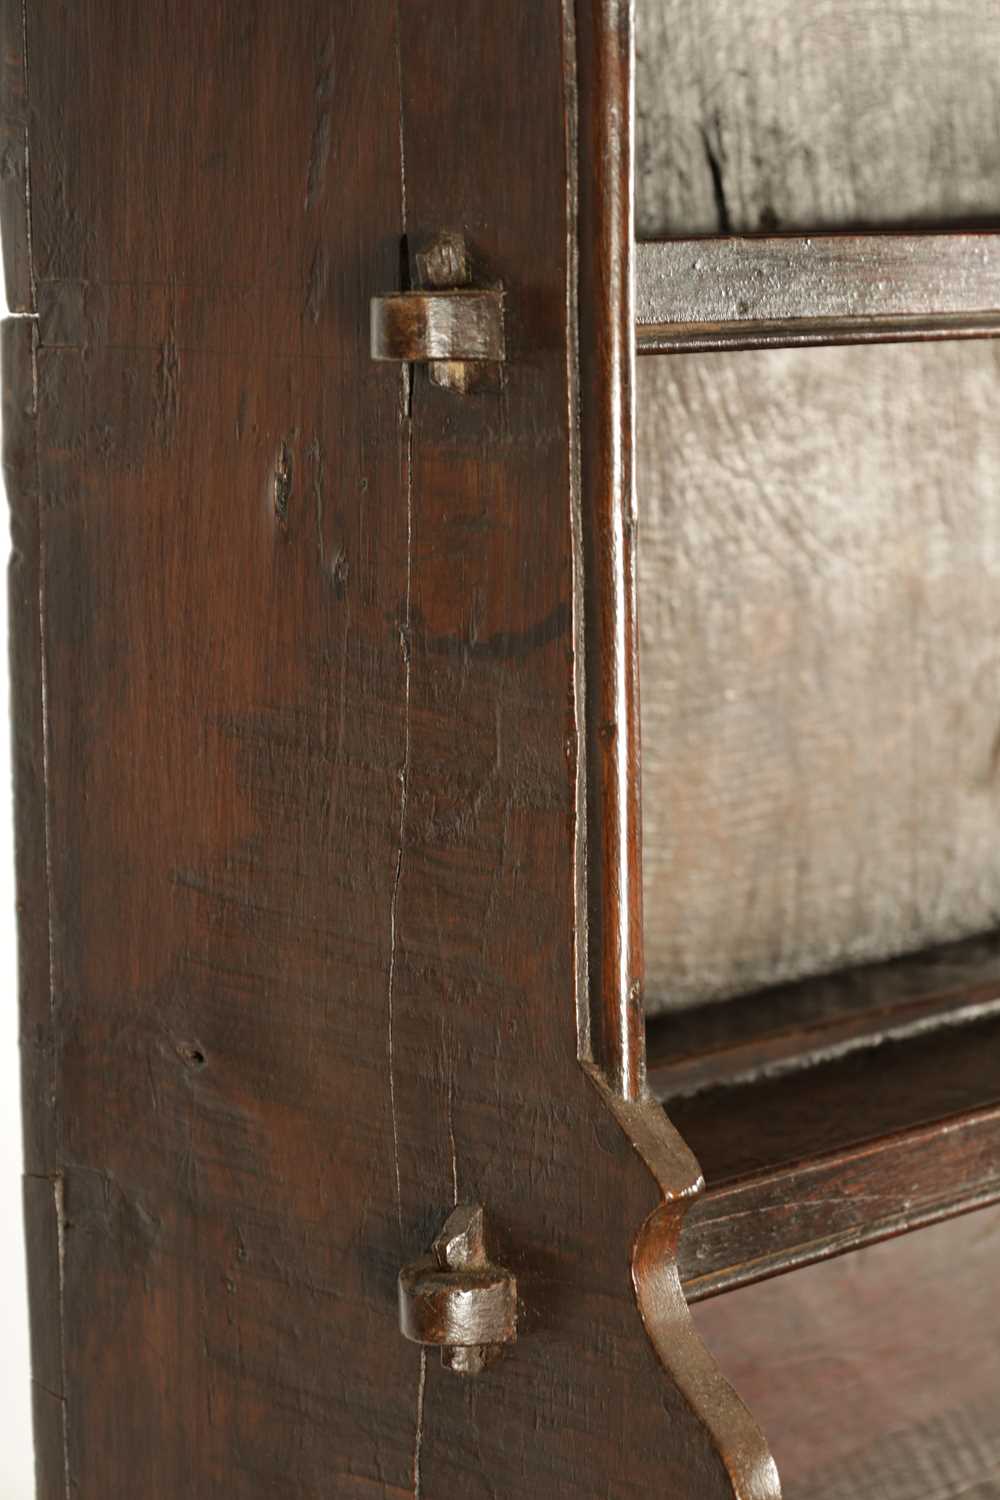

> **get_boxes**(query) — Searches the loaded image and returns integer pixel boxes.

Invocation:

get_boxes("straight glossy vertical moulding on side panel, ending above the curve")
[577,0,645,1100]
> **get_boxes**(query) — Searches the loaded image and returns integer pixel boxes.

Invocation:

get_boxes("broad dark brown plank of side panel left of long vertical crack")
[15,3,418,1497]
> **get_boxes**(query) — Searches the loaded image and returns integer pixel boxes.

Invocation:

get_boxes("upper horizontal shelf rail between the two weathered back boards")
[636,233,1000,354]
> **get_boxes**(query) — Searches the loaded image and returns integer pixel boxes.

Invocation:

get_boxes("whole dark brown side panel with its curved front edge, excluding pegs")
[4,0,777,1500]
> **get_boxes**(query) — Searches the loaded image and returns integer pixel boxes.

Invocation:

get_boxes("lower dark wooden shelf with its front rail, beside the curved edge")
[649,938,1000,1301]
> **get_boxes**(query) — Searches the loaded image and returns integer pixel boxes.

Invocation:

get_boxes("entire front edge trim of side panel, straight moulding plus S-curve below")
[576,0,781,1500]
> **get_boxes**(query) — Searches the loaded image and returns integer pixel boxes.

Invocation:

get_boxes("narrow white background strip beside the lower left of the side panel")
[0,276,34,1500]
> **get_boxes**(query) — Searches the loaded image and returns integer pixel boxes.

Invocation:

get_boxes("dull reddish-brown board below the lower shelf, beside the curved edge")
[694,1208,1000,1500]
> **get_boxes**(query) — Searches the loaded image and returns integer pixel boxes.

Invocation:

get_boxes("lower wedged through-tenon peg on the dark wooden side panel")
[399,1205,517,1376]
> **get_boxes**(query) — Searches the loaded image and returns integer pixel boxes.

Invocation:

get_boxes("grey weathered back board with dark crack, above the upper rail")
[636,0,1000,239]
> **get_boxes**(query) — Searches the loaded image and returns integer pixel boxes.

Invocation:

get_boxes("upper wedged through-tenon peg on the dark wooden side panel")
[372,234,505,393]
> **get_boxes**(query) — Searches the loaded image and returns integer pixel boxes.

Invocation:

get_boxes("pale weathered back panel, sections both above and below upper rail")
[639,0,1000,1010]
